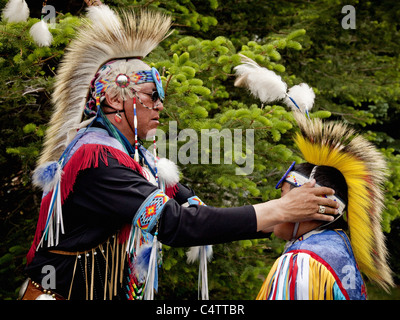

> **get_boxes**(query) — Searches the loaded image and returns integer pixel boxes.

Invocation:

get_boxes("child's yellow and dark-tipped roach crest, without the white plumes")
[294,112,393,290]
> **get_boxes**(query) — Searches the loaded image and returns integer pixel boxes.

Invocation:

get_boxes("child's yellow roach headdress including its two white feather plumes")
[235,57,393,290]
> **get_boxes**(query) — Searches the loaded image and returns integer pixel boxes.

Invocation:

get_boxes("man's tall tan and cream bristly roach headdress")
[38,5,171,167]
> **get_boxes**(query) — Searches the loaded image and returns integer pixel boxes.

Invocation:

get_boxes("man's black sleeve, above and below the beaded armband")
[72,158,263,246]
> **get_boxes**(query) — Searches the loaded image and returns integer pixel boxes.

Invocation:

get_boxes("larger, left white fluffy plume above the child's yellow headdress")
[234,55,287,103]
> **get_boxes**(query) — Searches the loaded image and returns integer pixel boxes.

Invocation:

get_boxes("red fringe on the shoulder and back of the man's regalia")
[26,144,143,264]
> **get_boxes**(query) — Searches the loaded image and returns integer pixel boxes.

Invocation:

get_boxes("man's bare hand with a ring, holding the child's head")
[254,180,339,231]
